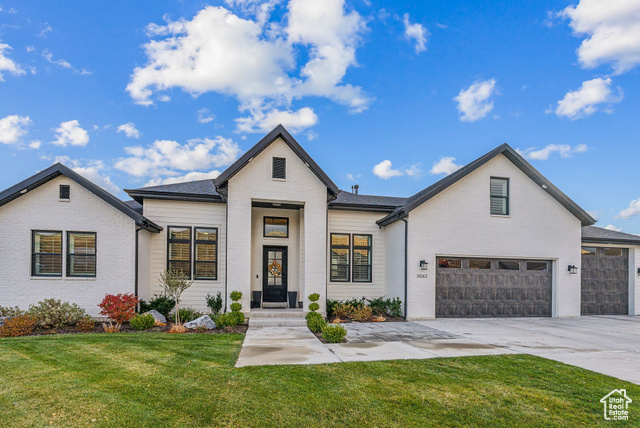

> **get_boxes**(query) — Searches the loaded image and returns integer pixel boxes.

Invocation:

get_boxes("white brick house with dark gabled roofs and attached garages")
[0,126,640,319]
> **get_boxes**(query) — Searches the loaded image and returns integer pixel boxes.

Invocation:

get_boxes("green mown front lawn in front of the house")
[0,333,640,428]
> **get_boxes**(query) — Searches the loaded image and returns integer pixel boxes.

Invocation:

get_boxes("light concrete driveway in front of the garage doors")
[416,316,640,387]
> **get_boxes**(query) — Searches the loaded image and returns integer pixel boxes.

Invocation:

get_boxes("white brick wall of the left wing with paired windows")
[0,176,136,316]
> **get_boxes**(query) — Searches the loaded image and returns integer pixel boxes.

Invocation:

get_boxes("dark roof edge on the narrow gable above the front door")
[214,125,339,195]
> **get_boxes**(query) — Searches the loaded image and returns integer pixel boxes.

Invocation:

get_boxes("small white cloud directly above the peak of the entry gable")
[236,107,318,132]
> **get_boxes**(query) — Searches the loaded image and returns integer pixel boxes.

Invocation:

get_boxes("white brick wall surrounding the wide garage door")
[408,155,581,319]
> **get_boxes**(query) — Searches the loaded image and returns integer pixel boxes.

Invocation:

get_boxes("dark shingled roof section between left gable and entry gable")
[125,180,223,203]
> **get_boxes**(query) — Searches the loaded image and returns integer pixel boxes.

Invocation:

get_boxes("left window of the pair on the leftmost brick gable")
[31,230,62,276]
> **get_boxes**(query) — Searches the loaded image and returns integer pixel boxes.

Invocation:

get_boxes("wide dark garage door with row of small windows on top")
[436,258,552,318]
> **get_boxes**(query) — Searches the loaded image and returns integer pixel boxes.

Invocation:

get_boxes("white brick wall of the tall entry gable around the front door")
[228,139,327,311]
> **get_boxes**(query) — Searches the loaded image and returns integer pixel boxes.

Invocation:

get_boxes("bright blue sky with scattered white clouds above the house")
[0,0,640,234]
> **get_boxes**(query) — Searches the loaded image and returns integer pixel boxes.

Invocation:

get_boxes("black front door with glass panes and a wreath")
[262,246,287,302]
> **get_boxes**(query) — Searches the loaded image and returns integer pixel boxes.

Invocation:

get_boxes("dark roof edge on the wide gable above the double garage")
[378,143,596,226]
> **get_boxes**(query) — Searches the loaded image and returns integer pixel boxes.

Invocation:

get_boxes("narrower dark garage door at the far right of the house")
[581,247,629,315]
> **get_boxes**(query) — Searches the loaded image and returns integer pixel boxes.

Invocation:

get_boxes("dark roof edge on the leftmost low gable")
[0,163,162,232]
